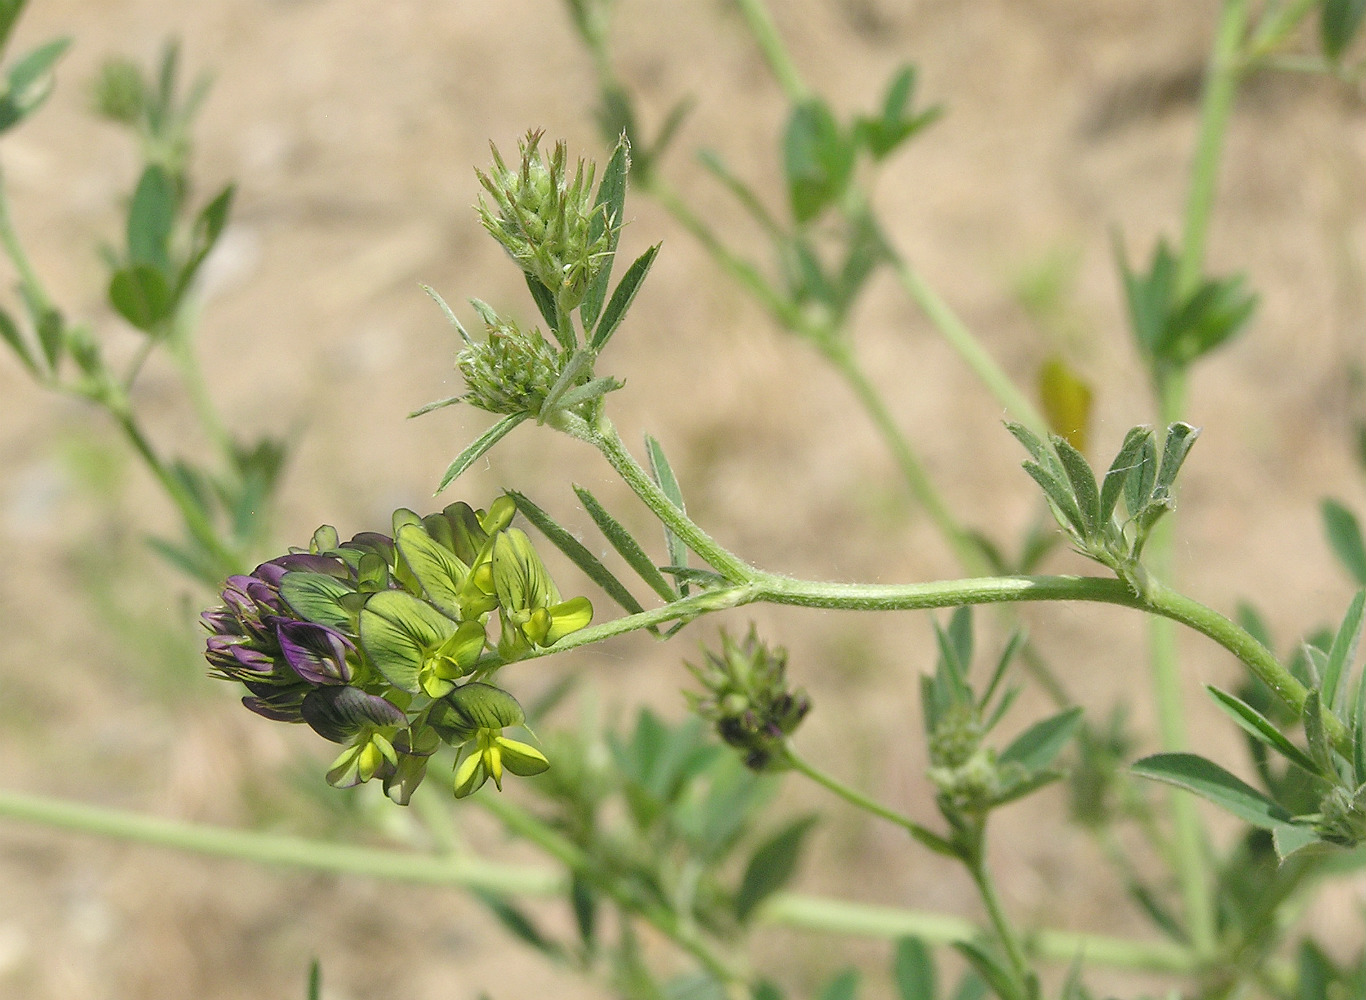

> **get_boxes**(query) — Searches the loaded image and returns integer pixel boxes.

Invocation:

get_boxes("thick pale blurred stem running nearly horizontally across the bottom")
[0,790,1194,973]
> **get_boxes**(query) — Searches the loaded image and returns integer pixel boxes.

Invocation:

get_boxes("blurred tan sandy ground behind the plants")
[0,0,1366,1000]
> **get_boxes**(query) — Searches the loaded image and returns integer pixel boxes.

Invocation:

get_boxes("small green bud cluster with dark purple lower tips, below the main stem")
[687,626,811,770]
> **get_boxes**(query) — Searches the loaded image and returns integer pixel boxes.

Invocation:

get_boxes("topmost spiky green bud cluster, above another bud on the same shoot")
[477,131,620,311]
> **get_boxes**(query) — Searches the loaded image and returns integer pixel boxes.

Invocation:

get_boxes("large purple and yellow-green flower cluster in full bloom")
[204,497,593,803]
